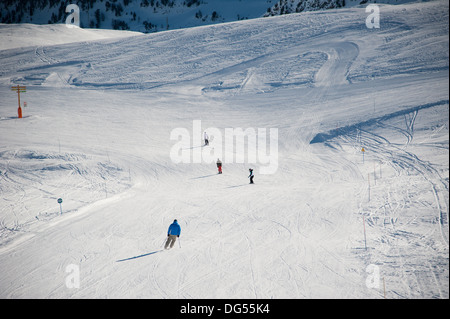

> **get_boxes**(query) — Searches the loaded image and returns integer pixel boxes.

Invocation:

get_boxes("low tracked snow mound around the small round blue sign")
[0,148,130,243]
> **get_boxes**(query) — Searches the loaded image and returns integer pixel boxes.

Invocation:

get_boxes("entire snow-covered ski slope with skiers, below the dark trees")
[0,1,449,298]
